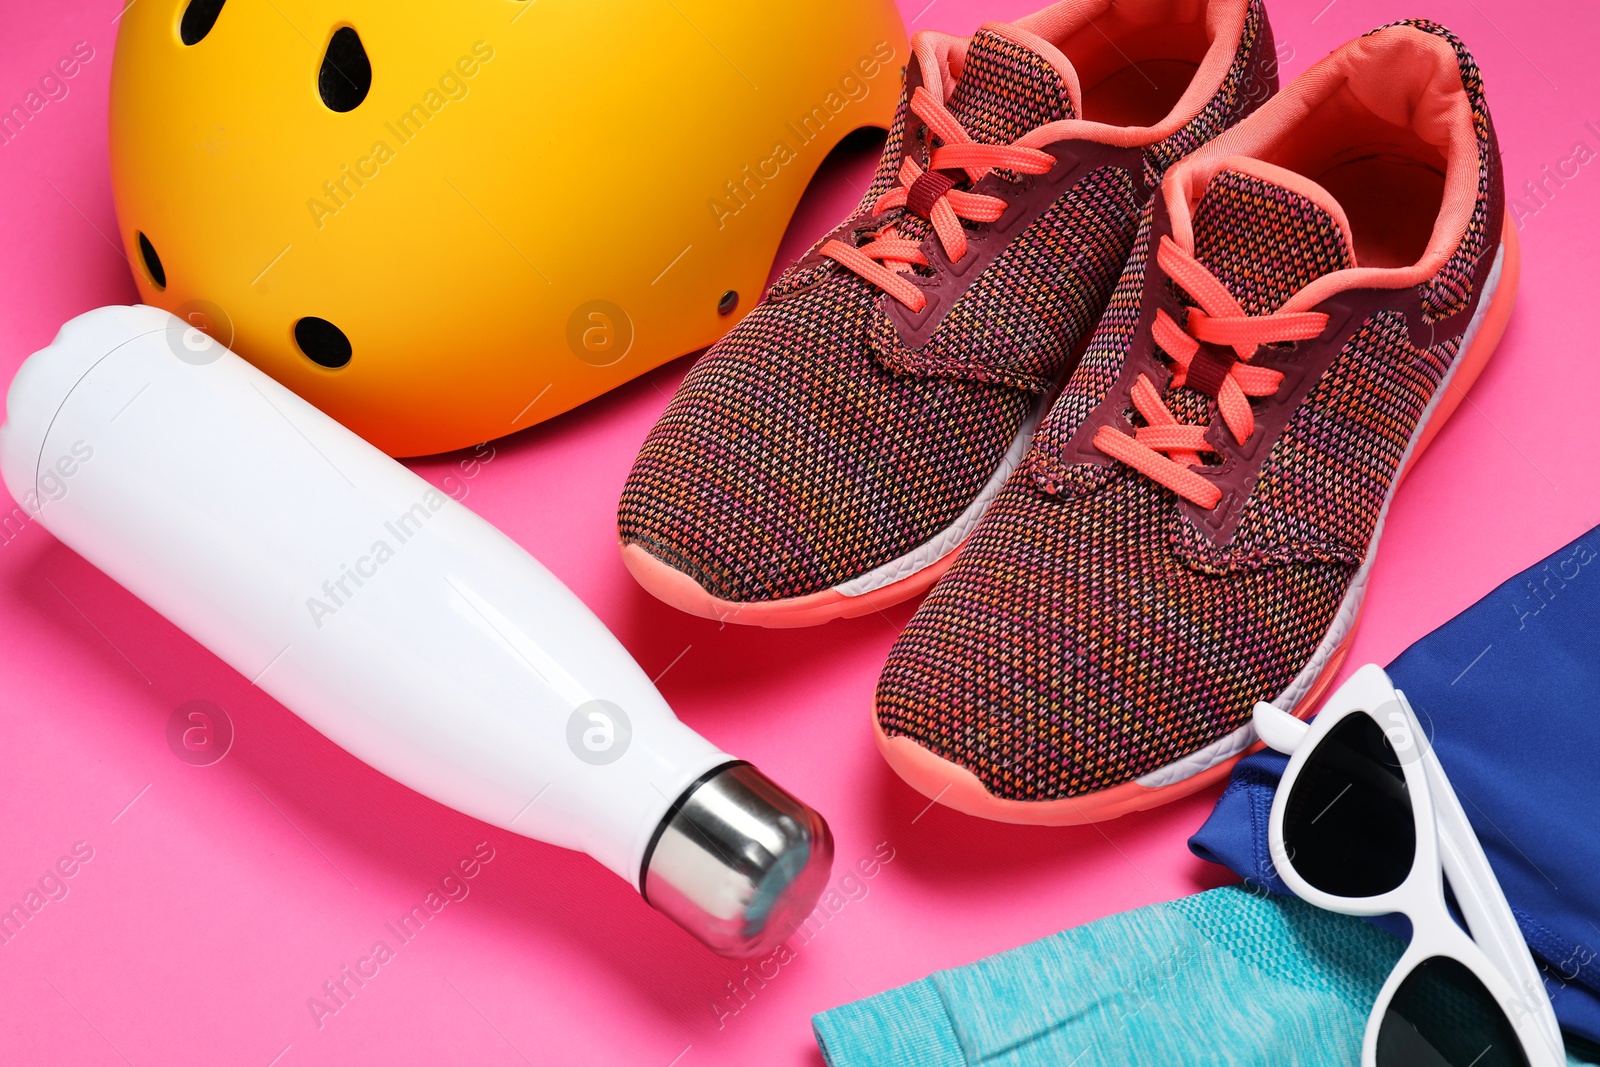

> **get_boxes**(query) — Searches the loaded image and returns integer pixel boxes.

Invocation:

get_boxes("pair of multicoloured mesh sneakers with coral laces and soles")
[618,0,1517,824]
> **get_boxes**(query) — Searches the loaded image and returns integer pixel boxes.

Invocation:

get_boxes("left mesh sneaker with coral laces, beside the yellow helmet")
[618,0,1277,625]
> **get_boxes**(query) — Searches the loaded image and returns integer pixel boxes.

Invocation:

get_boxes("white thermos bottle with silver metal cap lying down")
[9,307,832,957]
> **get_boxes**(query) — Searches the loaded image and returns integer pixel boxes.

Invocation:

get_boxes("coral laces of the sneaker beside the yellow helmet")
[821,86,1056,312]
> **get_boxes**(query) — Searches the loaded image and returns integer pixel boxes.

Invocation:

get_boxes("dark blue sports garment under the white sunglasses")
[1189,530,1600,1049]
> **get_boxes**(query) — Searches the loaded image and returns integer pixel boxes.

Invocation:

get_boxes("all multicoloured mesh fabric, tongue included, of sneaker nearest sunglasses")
[877,16,1493,801]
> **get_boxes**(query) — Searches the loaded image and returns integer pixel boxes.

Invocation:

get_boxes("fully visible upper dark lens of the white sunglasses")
[1283,713,1416,897]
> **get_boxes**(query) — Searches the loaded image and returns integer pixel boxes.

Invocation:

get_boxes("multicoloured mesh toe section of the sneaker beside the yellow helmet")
[618,277,1030,601]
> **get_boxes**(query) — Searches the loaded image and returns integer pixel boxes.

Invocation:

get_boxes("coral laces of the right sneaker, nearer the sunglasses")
[1094,237,1328,509]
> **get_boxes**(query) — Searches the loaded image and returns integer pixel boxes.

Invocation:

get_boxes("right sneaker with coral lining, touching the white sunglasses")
[875,21,1517,824]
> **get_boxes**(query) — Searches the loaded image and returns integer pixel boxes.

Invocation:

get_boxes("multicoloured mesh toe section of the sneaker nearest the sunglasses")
[877,472,1354,800]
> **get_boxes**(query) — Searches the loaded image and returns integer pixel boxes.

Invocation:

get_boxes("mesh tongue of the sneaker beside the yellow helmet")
[949,29,1077,144]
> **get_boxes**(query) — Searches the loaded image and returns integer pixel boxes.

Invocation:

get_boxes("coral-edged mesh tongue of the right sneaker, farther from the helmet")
[1194,160,1355,315]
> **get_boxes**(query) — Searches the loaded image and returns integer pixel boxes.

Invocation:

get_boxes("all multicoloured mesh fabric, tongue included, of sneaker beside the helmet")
[618,5,1270,601]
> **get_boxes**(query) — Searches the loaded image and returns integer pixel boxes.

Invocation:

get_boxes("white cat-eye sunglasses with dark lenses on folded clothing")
[1254,665,1566,1067]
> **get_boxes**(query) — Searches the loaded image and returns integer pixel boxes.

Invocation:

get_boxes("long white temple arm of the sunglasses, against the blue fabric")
[1422,749,1562,1049]
